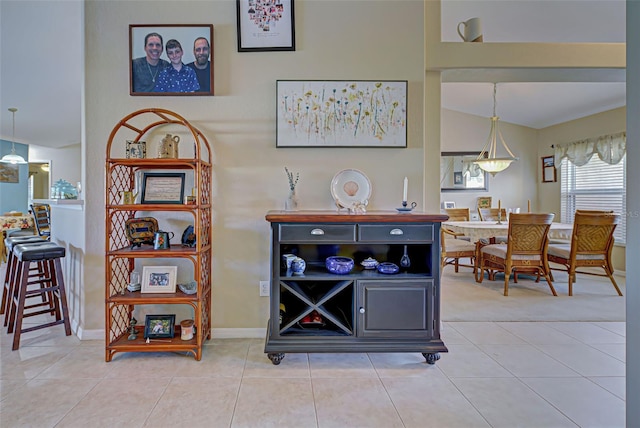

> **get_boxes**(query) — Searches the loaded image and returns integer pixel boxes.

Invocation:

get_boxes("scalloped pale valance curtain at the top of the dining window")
[554,131,627,166]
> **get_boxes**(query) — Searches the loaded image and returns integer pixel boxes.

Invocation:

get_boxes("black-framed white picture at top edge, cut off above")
[236,0,296,52]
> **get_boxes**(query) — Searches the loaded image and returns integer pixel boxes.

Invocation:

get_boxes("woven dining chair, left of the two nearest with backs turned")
[477,213,558,296]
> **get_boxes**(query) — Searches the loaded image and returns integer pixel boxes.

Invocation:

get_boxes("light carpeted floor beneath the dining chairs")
[441,266,626,322]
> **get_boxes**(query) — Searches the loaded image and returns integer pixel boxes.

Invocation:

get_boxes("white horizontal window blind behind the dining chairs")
[560,155,627,243]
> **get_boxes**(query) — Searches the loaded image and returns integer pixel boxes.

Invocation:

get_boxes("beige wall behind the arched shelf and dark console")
[83,0,424,330]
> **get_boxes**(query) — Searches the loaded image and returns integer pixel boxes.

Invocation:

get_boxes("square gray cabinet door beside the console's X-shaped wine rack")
[356,280,434,339]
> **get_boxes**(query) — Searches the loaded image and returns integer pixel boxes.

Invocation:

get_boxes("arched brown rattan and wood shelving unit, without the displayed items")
[105,108,212,361]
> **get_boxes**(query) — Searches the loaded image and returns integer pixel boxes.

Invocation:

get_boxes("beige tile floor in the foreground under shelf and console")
[0,316,625,428]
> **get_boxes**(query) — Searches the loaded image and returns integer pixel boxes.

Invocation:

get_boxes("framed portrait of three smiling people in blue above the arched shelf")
[129,24,213,96]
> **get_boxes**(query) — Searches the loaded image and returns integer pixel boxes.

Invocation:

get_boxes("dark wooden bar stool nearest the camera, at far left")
[7,242,71,351]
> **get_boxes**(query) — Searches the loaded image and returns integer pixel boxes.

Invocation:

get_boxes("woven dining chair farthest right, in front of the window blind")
[547,210,622,296]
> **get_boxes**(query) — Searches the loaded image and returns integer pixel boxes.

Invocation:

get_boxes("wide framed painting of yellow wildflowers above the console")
[276,80,407,148]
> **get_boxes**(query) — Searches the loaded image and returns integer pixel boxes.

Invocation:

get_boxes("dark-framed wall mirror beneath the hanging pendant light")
[440,152,489,192]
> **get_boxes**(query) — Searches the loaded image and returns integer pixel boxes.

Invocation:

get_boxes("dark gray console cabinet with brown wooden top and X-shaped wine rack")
[264,211,448,365]
